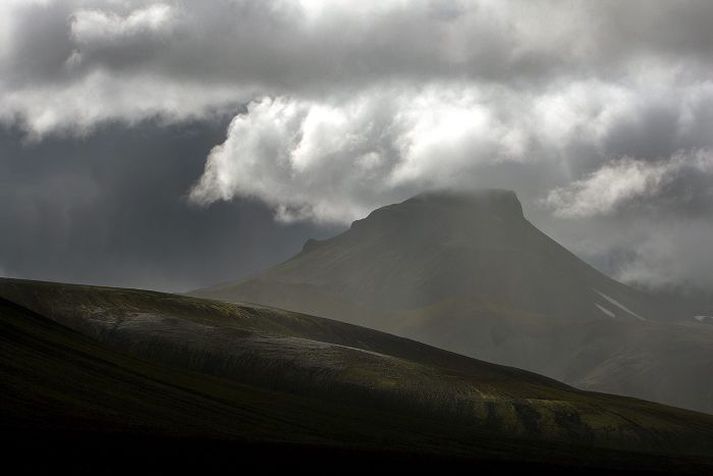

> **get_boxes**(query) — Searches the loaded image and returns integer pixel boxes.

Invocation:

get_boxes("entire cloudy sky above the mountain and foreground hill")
[0,0,713,291]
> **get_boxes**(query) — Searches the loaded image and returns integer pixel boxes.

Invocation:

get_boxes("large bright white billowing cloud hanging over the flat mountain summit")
[191,83,624,222]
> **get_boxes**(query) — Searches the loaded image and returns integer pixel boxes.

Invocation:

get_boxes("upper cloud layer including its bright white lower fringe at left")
[0,0,713,136]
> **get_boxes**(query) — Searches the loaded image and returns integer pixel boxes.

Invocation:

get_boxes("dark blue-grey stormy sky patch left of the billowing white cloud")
[0,121,328,291]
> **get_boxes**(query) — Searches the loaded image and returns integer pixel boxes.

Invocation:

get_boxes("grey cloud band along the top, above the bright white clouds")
[6,0,713,91]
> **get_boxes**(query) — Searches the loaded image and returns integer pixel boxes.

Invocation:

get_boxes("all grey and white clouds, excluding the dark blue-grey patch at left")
[0,0,713,285]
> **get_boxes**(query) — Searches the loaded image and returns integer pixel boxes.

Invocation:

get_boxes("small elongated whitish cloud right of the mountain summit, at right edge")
[546,150,713,218]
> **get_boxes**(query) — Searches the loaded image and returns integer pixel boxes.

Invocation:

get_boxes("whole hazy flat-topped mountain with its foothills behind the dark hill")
[194,190,713,412]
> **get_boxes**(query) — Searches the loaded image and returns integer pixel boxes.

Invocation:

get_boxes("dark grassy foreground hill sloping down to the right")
[0,280,713,474]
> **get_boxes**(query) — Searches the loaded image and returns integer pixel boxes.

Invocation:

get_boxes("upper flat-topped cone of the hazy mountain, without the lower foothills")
[199,190,660,321]
